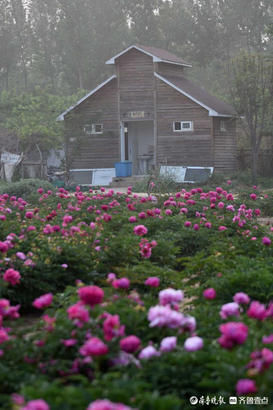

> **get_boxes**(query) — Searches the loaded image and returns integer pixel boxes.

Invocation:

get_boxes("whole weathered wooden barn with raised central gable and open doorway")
[58,45,237,183]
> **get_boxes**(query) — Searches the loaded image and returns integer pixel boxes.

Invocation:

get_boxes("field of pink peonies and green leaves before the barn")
[0,181,273,410]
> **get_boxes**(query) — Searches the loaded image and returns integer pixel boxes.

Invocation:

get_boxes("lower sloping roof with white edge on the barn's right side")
[155,73,237,117]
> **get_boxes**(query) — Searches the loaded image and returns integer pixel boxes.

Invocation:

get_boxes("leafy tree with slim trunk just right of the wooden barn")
[227,52,273,183]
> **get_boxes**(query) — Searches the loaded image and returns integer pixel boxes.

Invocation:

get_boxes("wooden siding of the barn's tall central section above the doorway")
[117,49,154,121]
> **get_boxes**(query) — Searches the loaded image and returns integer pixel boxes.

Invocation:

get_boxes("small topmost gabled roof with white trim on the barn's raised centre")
[105,44,191,67]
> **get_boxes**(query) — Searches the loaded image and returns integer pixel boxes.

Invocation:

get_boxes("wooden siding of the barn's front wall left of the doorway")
[65,80,120,169]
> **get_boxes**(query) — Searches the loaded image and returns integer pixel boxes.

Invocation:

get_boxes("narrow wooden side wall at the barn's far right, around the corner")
[213,118,237,174]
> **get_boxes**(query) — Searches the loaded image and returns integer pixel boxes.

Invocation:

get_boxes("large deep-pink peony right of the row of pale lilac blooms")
[218,322,248,349]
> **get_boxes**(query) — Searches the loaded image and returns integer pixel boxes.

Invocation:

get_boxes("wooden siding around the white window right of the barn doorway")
[157,79,213,166]
